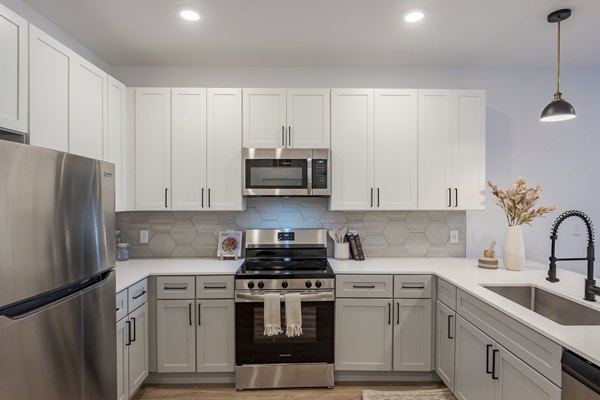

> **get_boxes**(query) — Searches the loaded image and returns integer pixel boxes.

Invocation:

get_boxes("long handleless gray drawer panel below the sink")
[456,289,562,387]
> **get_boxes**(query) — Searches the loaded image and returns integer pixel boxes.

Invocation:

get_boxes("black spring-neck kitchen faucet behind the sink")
[546,210,600,301]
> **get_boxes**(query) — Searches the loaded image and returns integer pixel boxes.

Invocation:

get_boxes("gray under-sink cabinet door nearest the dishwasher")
[494,346,561,400]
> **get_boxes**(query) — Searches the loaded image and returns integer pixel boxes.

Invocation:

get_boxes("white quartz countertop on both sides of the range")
[116,257,600,365]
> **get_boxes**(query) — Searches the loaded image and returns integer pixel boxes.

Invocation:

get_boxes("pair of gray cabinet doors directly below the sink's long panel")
[454,316,561,400]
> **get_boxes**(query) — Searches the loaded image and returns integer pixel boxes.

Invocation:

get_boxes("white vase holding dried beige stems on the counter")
[488,177,556,271]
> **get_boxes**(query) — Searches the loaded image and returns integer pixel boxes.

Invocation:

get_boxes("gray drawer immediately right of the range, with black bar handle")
[335,275,394,298]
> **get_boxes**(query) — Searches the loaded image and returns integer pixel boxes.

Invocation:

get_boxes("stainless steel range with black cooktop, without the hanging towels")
[235,229,335,390]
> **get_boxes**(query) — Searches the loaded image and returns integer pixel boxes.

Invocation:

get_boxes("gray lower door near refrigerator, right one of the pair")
[129,303,148,395]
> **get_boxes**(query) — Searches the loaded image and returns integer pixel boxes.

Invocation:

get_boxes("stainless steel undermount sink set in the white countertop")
[482,285,600,325]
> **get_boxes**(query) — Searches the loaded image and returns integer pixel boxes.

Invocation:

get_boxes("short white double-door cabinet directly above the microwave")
[243,89,330,148]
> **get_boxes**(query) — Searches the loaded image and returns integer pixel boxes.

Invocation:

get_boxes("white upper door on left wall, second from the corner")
[69,55,107,160]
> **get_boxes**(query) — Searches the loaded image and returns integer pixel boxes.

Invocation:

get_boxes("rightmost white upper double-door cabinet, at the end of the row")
[418,90,485,210]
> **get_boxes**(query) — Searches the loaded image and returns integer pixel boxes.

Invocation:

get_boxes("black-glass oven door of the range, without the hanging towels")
[235,291,335,366]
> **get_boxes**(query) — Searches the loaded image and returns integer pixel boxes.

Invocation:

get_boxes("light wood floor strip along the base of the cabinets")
[134,382,441,400]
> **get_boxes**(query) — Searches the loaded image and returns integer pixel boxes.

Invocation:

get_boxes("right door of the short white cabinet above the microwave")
[287,89,331,149]
